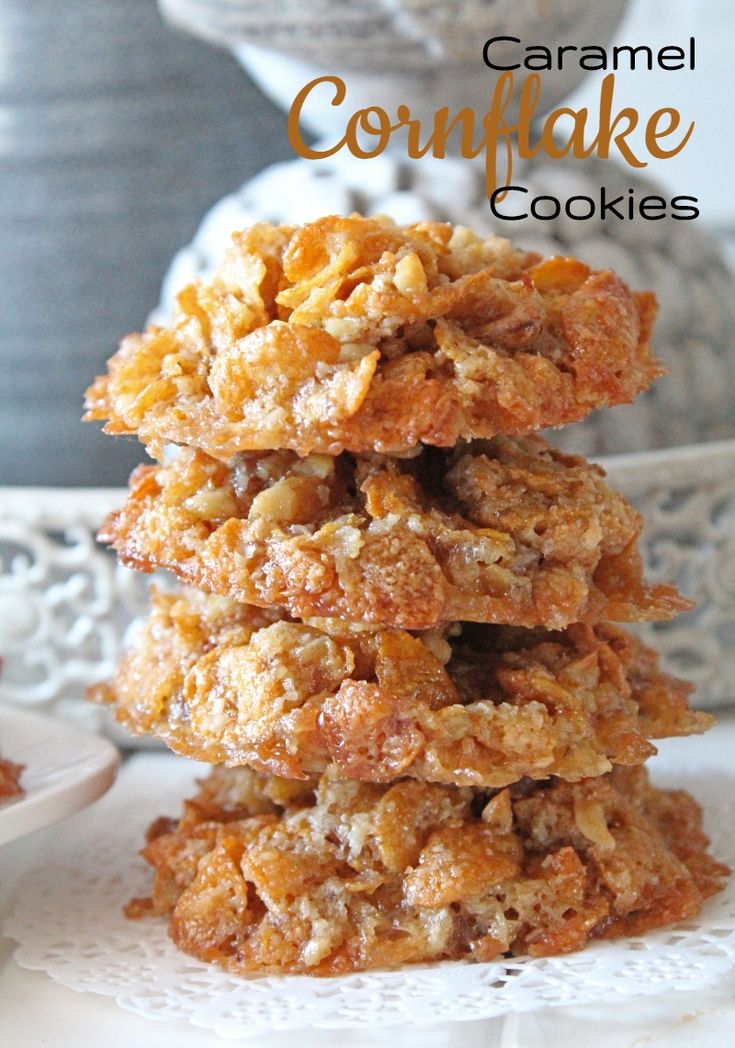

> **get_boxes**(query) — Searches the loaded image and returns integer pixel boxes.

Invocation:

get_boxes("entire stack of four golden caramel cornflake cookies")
[87,216,725,975]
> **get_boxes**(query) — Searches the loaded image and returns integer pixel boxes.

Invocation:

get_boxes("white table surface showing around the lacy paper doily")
[0,714,735,1048]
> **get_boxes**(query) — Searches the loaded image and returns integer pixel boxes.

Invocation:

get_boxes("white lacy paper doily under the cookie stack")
[5,746,735,1038]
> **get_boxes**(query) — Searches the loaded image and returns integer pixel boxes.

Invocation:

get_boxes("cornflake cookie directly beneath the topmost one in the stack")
[100,437,691,629]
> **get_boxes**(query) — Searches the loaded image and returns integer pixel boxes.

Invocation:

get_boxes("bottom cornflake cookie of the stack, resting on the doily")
[127,768,728,976]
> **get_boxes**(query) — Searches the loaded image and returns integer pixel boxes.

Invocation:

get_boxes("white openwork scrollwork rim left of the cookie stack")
[0,488,155,729]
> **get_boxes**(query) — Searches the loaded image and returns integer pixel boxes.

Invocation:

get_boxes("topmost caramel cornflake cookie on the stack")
[85,215,662,461]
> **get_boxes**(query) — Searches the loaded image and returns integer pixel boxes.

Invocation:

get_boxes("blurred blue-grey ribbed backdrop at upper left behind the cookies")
[0,0,291,485]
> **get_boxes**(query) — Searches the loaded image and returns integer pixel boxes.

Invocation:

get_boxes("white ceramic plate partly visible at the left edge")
[0,705,120,845]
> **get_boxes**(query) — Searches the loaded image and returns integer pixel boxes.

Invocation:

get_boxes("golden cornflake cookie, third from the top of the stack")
[92,592,712,786]
